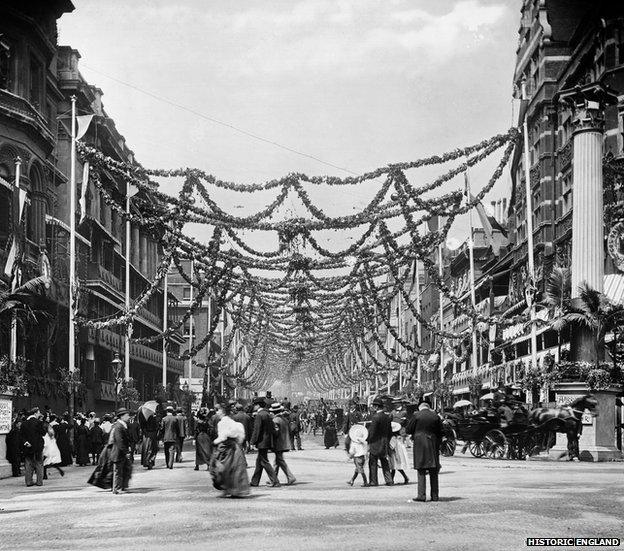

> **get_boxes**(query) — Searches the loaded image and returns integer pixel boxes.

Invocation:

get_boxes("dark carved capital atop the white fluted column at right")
[557,83,617,133]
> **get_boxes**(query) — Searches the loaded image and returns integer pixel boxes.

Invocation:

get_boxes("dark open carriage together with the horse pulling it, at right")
[440,395,596,459]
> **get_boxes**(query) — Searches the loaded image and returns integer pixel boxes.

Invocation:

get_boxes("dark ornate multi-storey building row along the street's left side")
[0,0,183,422]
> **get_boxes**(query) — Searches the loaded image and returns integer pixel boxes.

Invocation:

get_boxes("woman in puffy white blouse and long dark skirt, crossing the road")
[210,405,249,497]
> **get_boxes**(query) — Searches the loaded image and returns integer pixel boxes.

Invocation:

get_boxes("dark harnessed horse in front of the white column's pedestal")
[529,394,598,461]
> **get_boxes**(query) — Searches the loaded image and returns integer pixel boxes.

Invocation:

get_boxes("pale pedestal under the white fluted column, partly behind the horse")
[550,382,624,461]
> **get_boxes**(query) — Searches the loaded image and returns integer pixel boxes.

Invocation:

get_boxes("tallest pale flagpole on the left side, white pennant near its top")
[68,96,77,419]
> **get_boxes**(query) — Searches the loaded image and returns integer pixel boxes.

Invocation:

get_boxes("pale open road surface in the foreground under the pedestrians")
[0,437,624,551]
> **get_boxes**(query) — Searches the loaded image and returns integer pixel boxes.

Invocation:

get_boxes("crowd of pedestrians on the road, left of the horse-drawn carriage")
[7,392,443,501]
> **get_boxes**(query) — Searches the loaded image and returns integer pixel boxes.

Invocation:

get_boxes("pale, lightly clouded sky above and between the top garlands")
[59,0,521,250]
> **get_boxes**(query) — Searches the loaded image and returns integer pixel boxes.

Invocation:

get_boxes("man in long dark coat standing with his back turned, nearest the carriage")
[405,402,442,501]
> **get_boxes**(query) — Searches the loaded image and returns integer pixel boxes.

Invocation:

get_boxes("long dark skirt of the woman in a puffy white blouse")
[210,438,249,497]
